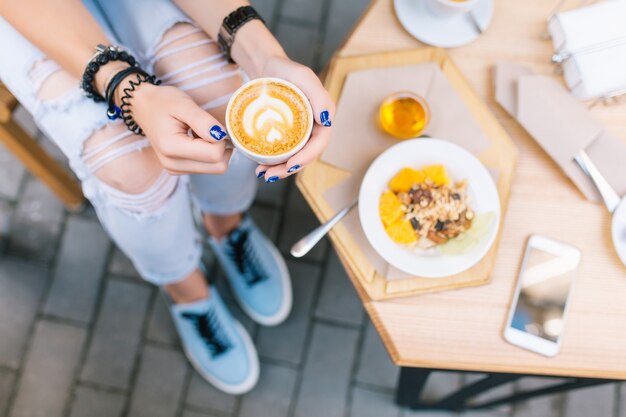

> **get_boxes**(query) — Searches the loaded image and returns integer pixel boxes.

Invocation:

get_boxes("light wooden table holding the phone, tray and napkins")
[298,0,626,408]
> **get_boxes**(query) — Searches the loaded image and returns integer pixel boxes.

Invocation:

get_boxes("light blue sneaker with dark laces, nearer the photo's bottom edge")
[163,287,259,394]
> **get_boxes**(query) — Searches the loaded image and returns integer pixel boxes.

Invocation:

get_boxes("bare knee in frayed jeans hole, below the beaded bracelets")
[82,123,178,214]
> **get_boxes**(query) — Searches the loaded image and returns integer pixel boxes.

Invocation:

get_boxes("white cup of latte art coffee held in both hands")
[226,78,314,165]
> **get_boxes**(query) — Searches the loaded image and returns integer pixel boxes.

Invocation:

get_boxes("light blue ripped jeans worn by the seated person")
[0,0,257,285]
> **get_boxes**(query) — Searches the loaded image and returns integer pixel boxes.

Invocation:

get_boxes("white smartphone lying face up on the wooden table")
[504,235,581,356]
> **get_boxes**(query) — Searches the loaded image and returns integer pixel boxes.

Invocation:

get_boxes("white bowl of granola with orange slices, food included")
[359,139,500,278]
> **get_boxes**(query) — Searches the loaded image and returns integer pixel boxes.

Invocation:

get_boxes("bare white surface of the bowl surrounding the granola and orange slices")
[359,139,500,278]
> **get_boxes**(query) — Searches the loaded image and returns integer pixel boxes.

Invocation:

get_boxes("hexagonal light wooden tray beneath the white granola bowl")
[296,48,517,300]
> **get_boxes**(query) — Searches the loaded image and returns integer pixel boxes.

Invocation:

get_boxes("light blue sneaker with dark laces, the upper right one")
[209,215,292,326]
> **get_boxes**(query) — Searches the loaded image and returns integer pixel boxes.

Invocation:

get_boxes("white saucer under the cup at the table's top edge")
[394,0,494,48]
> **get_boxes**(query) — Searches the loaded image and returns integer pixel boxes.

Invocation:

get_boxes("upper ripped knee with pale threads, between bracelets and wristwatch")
[152,23,243,122]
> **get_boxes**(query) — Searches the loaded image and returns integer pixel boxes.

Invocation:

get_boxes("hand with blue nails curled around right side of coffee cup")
[251,56,335,182]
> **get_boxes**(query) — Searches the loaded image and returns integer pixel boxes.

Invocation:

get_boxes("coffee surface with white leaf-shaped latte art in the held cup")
[229,81,311,155]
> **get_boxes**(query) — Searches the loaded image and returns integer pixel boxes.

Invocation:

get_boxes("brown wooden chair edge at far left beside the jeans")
[0,83,84,211]
